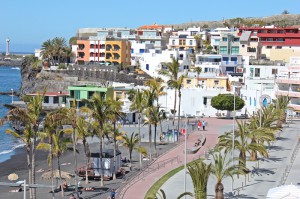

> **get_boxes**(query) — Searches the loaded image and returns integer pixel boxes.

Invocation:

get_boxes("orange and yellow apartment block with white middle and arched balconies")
[76,38,131,65]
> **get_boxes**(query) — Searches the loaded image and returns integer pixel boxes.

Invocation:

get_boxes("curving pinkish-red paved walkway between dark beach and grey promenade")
[120,118,232,199]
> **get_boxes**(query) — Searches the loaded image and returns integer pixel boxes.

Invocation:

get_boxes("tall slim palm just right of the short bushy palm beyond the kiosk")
[128,90,144,167]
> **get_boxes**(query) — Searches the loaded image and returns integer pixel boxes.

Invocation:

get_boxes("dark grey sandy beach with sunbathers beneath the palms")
[0,138,175,199]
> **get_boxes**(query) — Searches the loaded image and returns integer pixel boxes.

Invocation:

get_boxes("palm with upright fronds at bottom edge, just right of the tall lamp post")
[187,159,212,199]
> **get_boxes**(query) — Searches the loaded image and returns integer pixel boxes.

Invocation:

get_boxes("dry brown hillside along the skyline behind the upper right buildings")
[172,14,300,29]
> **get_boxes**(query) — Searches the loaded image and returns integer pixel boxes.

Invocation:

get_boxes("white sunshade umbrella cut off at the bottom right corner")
[267,185,300,199]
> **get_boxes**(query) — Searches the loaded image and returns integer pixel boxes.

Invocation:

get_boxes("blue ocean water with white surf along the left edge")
[0,67,24,162]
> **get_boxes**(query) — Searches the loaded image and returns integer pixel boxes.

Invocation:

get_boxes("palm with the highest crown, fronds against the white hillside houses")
[159,58,179,134]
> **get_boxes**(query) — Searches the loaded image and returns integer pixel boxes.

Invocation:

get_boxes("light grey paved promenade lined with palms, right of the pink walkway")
[161,121,300,199]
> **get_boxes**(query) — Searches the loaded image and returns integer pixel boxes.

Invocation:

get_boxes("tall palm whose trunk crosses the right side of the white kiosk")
[108,99,123,179]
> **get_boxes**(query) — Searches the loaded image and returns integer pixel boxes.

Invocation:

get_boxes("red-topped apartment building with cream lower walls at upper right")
[238,26,300,63]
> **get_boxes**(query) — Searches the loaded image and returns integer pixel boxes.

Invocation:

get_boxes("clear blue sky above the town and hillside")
[0,0,300,52]
